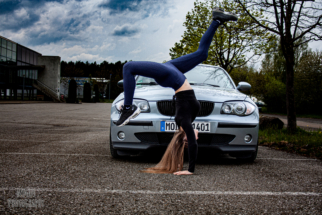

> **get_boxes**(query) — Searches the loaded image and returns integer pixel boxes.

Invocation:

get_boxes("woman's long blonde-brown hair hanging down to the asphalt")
[141,130,185,173]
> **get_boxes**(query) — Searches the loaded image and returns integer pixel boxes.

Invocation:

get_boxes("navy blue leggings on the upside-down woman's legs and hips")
[123,21,220,105]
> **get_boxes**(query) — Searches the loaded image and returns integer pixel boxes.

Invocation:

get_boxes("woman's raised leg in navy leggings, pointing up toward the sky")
[168,21,220,73]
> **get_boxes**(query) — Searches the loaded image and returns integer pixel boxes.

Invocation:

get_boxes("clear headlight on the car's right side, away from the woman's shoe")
[221,102,255,116]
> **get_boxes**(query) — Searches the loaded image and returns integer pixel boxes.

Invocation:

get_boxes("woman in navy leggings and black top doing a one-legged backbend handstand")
[116,8,237,175]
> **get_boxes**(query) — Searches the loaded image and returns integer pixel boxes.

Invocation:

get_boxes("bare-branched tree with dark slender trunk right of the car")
[235,0,322,133]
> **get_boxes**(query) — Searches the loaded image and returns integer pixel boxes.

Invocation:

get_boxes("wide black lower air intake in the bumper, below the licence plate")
[135,132,235,145]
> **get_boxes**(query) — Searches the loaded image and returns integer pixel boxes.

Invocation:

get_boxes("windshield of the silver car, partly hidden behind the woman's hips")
[136,66,234,89]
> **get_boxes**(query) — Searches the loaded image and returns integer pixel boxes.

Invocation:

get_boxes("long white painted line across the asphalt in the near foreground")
[0,187,322,196]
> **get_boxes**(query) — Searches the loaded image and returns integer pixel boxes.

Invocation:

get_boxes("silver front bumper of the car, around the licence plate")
[111,102,259,153]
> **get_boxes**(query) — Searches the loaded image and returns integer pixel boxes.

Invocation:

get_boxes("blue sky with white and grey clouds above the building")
[0,0,322,63]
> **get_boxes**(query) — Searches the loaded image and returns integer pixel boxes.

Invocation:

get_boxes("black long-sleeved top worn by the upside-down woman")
[174,90,200,172]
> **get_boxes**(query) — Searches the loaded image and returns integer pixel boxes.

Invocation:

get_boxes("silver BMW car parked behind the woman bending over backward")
[110,64,259,162]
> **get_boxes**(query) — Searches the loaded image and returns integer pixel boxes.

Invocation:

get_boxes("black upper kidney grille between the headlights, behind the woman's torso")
[157,100,214,116]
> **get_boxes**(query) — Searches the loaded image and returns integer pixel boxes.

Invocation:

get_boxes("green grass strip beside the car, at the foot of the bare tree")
[259,127,322,160]
